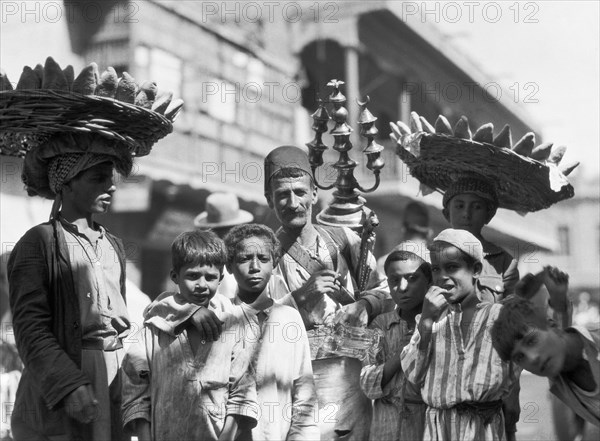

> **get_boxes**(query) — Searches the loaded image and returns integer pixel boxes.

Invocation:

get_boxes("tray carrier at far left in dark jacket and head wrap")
[8,149,130,440]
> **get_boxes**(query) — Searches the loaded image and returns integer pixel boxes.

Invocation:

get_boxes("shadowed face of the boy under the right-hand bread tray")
[448,193,488,236]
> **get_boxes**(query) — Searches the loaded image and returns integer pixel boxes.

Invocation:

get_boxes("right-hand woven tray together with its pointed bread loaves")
[390,112,579,213]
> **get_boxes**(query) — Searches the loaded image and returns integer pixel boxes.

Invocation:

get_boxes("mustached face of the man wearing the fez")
[268,175,317,230]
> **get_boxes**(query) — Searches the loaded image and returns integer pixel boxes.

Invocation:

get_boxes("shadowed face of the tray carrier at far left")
[63,162,116,215]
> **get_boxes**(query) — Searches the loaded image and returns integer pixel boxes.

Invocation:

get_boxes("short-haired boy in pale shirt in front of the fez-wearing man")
[225,224,320,441]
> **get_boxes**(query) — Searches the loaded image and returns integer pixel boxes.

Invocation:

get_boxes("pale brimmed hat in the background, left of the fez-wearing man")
[194,193,254,228]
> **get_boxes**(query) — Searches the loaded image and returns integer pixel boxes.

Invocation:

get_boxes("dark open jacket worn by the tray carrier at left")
[8,221,125,439]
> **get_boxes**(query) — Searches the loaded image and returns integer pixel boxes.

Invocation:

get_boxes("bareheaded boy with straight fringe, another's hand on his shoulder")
[123,231,257,440]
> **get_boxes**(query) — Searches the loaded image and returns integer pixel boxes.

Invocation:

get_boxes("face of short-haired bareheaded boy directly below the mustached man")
[227,236,273,294]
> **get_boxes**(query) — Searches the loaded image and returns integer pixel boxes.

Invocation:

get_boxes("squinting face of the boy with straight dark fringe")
[171,265,223,307]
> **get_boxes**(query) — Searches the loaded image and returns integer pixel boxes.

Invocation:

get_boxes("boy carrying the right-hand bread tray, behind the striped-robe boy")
[442,175,519,300]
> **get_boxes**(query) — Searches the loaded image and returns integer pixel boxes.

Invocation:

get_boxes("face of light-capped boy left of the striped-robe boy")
[386,259,429,311]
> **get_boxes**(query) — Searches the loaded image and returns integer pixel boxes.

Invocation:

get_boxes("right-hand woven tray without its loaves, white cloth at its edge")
[397,132,574,212]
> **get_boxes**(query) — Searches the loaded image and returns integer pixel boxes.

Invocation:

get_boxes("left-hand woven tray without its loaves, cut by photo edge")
[0,89,173,156]
